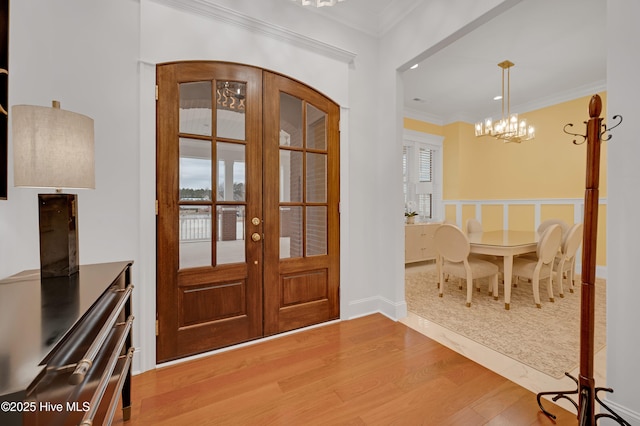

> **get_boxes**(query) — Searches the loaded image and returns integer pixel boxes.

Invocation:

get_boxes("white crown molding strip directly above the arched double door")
[151,0,356,64]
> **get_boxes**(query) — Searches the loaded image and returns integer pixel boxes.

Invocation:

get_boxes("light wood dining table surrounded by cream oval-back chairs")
[467,229,539,310]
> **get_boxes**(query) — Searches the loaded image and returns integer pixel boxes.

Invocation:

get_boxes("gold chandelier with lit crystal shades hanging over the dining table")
[476,61,536,143]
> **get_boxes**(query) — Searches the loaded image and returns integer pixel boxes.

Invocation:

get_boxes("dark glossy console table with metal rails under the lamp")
[0,262,134,425]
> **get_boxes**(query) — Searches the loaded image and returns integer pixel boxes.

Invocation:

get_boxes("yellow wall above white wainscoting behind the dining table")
[443,94,607,200]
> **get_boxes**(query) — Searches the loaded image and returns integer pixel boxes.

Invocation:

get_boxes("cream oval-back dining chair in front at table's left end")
[435,225,499,307]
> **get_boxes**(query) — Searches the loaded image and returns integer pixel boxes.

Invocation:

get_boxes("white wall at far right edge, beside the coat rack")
[604,0,640,425]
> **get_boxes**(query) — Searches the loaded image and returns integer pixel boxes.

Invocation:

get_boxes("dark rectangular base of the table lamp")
[38,194,80,278]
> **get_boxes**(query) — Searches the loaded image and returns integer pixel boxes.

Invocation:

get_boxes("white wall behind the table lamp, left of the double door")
[0,0,138,277]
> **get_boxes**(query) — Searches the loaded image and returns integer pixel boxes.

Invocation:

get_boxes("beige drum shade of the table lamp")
[11,101,96,189]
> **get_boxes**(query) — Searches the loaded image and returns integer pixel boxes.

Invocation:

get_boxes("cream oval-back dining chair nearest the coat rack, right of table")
[512,224,562,308]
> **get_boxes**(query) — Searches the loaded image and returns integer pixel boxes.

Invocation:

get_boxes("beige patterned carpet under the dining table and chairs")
[405,270,606,378]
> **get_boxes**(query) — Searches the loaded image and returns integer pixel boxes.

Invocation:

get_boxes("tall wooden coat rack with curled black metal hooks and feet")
[537,95,631,426]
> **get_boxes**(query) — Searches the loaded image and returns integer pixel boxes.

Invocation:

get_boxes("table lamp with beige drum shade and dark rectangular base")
[11,101,95,278]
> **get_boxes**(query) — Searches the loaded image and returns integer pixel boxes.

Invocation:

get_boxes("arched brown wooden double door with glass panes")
[156,61,339,362]
